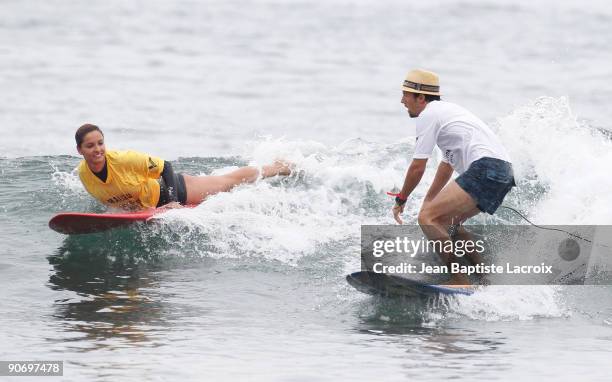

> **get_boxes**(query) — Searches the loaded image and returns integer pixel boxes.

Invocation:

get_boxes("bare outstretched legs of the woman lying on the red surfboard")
[183,161,291,204]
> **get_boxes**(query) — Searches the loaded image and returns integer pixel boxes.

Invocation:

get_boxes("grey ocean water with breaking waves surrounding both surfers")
[0,0,612,381]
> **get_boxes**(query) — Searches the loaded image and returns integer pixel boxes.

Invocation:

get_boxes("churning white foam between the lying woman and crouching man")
[155,139,420,264]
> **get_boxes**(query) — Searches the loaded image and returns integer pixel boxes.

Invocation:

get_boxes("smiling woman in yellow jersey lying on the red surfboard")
[75,124,291,211]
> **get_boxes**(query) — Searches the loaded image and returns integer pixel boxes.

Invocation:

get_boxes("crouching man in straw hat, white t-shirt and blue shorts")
[392,69,516,285]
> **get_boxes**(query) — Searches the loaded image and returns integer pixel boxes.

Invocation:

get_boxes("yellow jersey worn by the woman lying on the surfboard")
[78,150,164,211]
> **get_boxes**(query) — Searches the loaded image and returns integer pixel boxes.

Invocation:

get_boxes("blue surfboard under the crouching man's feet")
[346,271,474,297]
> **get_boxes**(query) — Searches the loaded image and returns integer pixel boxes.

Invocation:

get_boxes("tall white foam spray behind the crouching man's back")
[499,97,612,225]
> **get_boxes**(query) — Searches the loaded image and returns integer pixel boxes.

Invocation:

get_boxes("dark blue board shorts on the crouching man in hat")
[455,157,516,215]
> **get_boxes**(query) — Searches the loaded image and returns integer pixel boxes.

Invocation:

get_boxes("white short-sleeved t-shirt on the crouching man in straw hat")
[413,101,510,174]
